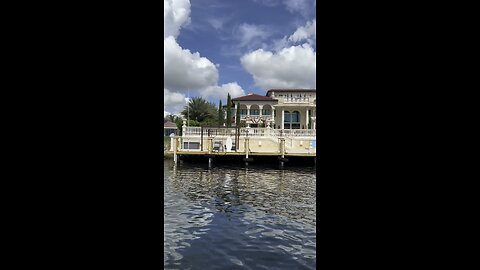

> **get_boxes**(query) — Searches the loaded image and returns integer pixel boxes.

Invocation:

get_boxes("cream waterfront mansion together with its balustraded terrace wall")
[169,89,317,158]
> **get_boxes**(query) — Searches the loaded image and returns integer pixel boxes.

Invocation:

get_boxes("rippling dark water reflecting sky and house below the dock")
[164,160,316,269]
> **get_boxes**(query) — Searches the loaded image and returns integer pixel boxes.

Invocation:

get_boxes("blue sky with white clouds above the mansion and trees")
[163,0,316,116]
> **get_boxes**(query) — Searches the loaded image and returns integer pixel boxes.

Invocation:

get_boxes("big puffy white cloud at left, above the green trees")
[163,37,218,91]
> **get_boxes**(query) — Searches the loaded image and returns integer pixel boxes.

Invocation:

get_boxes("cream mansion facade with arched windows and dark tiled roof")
[232,89,317,129]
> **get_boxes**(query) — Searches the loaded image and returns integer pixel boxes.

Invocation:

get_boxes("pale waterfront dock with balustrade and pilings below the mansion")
[164,126,317,167]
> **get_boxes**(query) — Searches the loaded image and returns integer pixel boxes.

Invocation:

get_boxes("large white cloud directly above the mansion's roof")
[240,44,316,89]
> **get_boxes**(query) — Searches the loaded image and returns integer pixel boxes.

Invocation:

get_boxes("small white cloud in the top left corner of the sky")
[163,0,191,39]
